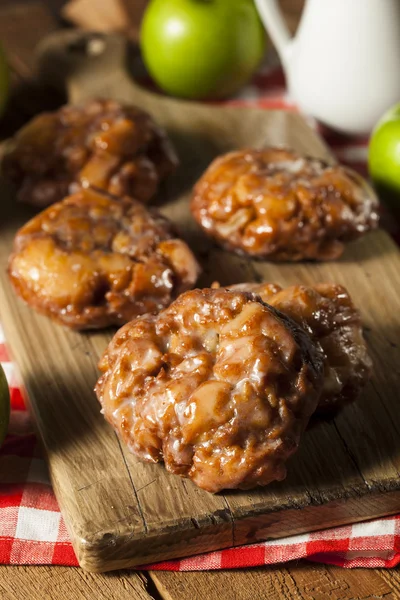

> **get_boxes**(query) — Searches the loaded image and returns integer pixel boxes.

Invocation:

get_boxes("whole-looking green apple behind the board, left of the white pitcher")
[141,0,266,99]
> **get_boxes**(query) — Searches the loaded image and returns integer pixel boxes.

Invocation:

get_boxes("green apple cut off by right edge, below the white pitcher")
[368,104,400,211]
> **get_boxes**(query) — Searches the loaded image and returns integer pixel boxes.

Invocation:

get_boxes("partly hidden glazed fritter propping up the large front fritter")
[229,283,372,413]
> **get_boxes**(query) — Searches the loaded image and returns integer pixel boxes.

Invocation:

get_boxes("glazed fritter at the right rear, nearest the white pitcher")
[191,148,379,261]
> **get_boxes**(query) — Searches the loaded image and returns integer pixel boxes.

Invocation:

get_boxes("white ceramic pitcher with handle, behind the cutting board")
[255,0,400,134]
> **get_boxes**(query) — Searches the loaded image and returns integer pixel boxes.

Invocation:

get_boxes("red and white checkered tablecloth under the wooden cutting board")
[0,66,400,571]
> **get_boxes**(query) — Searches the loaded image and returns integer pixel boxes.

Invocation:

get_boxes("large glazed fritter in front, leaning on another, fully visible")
[96,289,322,492]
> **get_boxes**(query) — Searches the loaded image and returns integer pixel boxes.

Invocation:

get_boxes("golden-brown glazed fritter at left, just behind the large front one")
[9,190,199,329]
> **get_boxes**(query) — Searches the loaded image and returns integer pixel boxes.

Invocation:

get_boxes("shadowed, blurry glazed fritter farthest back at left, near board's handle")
[2,100,177,208]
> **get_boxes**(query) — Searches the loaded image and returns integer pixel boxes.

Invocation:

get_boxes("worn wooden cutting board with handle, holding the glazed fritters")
[0,32,400,571]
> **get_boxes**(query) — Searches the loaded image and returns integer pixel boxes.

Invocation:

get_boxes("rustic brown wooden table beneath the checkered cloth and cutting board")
[0,0,400,600]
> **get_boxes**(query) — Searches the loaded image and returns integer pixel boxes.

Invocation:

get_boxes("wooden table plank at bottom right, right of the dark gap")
[150,561,399,600]
